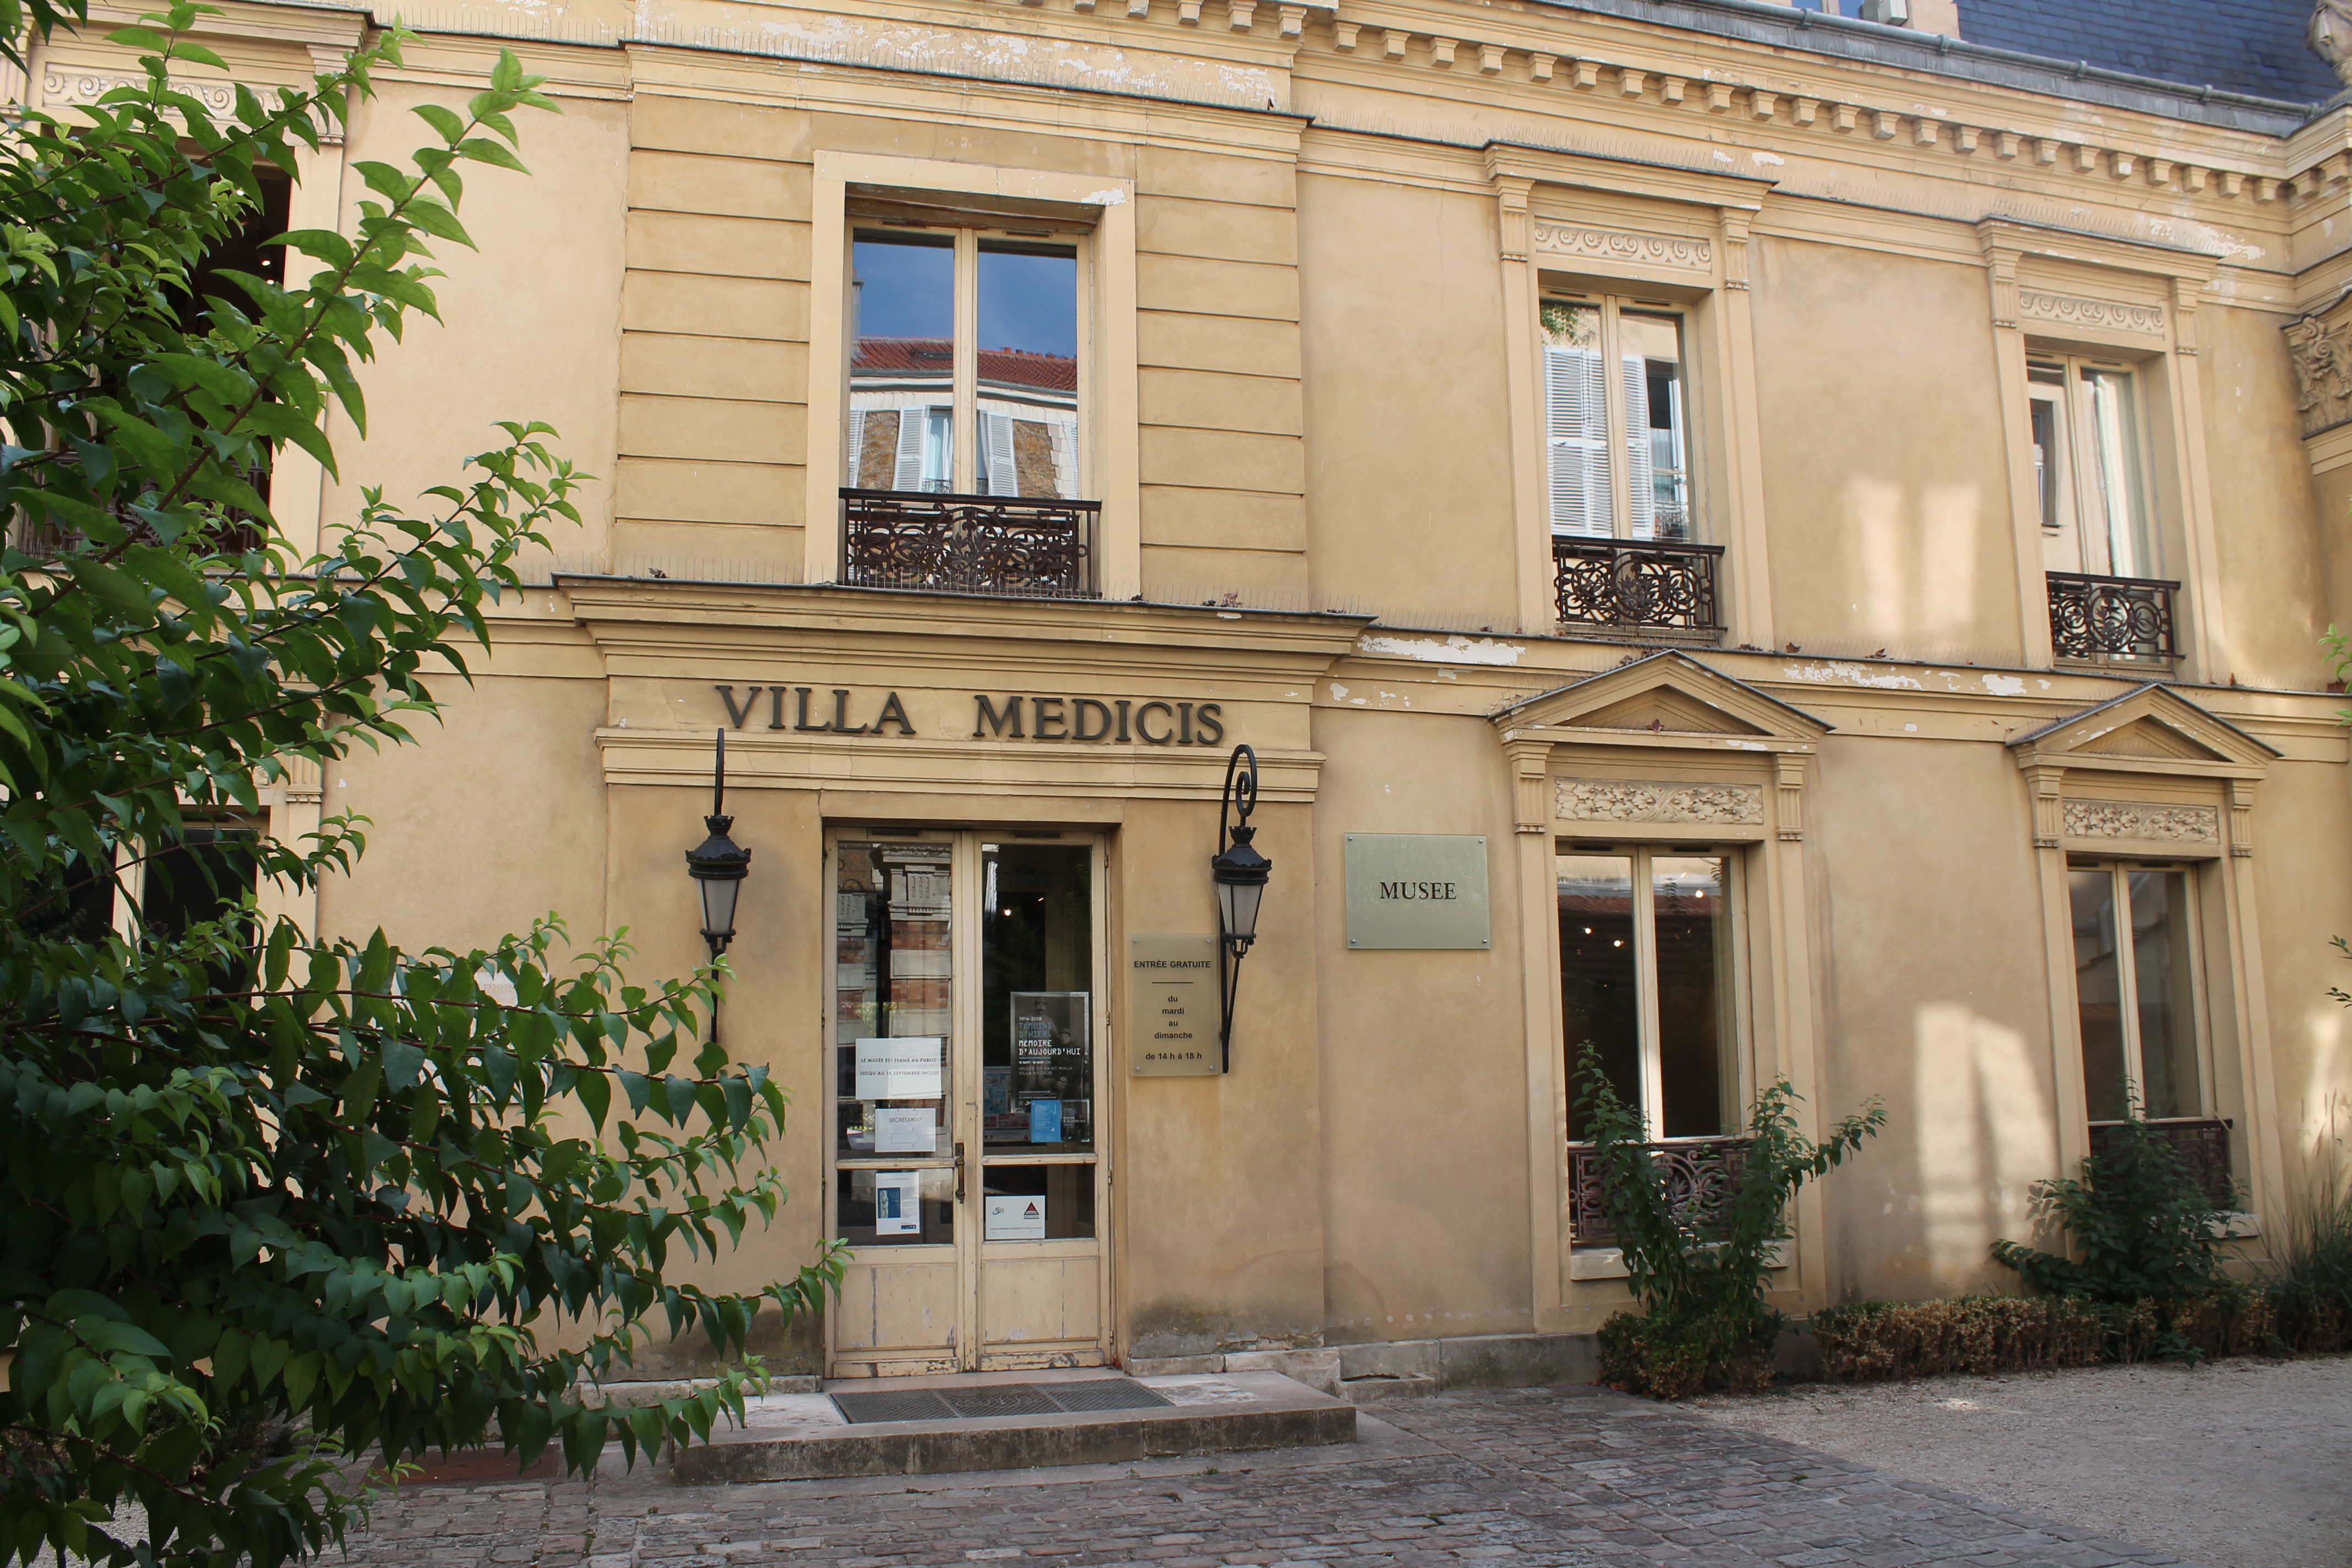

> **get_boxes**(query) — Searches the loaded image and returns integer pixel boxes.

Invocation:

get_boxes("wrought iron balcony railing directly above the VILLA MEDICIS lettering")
[842,489,1103,600]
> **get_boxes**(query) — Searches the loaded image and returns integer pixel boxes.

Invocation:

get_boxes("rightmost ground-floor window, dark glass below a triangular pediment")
[2067,861,2204,1121]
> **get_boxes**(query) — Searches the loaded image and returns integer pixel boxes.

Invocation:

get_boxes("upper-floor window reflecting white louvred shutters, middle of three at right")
[1543,296,1691,538]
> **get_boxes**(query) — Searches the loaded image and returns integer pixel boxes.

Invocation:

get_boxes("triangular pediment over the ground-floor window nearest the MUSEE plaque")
[1494,651,1830,750]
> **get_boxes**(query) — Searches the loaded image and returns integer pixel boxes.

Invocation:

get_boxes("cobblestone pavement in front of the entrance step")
[346,1389,2178,1568]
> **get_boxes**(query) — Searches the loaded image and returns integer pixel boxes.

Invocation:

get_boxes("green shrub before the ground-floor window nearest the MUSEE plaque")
[1576,1042,1886,1399]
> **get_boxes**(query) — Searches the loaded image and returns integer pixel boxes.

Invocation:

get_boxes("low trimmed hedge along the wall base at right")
[1811,1291,2286,1382]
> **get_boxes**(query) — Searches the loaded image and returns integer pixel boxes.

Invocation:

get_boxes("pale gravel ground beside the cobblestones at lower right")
[1684,1357,2352,1568]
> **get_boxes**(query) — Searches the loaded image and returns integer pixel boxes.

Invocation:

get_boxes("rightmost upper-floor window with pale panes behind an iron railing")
[2025,357,2162,578]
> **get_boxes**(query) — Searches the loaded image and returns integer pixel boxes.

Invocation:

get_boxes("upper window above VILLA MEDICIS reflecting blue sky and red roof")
[847,226,1082,500]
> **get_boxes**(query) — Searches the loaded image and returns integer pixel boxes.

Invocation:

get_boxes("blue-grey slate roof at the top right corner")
[1959,0,2343,104]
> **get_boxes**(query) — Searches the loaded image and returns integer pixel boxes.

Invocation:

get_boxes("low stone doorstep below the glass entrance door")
[671,1370,1355,1486]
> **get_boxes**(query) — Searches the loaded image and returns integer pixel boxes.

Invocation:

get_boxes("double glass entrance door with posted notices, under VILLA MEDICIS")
[825,827,1110,1378]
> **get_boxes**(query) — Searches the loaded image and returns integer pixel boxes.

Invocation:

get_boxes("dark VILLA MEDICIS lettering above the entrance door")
[712,687,1226,745]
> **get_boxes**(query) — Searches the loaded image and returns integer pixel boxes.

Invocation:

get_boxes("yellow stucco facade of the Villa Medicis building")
[21,0,2352,1378]
